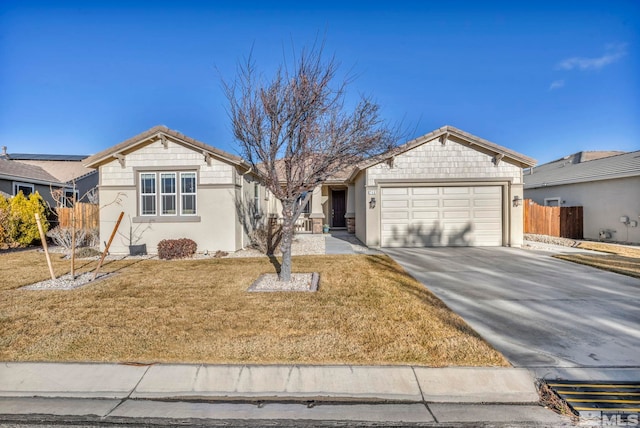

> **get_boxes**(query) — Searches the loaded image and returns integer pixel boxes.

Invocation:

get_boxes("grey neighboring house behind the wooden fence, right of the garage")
[524,151,640,243]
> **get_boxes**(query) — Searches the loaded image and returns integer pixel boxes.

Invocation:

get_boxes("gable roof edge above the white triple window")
[84,125,250,169]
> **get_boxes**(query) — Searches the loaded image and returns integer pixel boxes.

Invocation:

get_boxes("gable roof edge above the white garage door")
[350,125,536,180]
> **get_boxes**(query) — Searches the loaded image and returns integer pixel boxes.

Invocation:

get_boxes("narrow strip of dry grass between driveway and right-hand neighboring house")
[555,241,640,278]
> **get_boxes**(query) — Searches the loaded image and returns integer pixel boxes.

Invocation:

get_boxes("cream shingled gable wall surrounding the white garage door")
[356,138,523,247]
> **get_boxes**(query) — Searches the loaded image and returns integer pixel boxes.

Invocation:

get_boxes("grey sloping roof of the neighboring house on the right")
[524,151,640,189]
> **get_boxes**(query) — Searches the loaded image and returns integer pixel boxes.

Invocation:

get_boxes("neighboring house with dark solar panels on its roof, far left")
[0,147,98,208]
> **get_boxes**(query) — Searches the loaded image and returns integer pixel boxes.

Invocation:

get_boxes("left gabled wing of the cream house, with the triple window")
[85,126,268,253]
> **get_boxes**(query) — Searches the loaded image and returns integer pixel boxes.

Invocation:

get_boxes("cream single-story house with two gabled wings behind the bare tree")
[85,126,535,253]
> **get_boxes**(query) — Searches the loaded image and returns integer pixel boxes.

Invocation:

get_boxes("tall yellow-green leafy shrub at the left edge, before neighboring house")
[0,192,49,246]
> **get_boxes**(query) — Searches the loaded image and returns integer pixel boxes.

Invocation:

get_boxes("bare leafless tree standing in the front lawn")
[223,46,396,281]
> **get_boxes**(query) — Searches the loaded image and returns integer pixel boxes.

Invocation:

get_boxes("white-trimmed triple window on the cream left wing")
[138,171,197,216]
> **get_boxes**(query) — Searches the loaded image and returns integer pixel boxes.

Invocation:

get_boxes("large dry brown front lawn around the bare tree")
[0,251,508,366]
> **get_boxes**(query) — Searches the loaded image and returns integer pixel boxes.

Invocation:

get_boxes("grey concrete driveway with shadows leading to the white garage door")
[385,247,640,380]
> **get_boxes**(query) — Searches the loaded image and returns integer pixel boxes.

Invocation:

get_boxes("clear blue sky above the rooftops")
[0,0,640,163]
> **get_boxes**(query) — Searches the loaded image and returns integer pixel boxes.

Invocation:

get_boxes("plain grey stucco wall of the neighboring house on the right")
[524,176,640,243]
